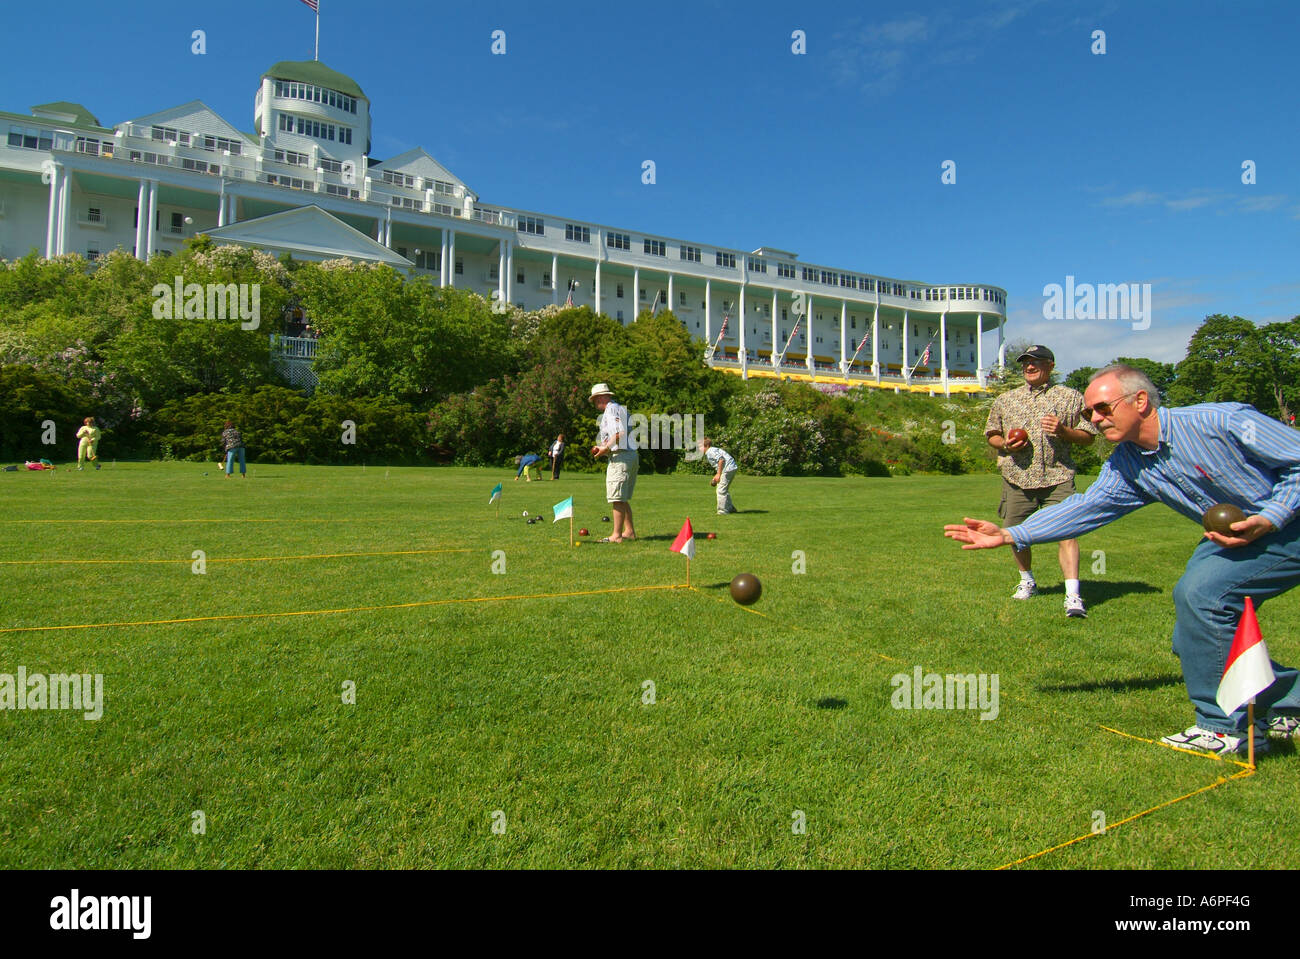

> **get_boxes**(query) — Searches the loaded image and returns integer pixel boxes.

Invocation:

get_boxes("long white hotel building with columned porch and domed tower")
[0,61,1006,391]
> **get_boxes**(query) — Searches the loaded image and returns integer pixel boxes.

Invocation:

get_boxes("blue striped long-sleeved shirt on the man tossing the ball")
[1008,403,1300,550]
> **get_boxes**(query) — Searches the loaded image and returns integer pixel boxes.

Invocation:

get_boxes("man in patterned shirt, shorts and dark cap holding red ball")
[984,346,1097,617]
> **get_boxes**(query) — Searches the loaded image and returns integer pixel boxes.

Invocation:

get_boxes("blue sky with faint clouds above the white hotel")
[0,0,1300,370]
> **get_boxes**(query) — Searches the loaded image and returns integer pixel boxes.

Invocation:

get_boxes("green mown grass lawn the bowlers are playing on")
[0,463,1300,868]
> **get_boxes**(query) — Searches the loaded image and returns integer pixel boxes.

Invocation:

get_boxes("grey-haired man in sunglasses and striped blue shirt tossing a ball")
[944,365,1300,752]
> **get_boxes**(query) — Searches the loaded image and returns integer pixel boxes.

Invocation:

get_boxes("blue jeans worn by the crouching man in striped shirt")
[1174,521,1300,733]
